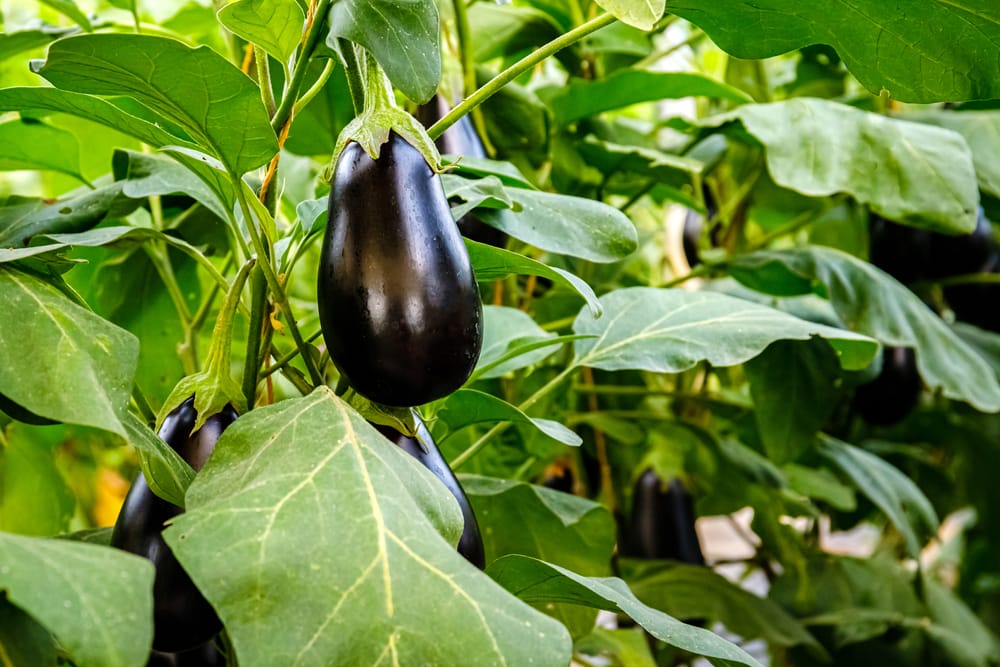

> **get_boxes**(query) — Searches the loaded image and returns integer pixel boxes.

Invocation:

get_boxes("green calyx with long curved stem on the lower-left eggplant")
[156,259,256,432]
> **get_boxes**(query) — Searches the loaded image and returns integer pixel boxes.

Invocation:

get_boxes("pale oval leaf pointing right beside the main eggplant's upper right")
[479,189,638,262]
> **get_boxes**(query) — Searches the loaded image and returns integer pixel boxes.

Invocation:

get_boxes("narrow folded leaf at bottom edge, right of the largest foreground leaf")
[487,555,761,667]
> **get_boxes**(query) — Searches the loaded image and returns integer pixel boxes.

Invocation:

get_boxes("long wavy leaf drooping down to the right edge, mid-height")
[731,246,1000,412]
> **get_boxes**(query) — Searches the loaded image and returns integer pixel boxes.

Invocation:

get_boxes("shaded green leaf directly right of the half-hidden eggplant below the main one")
[462,475,615,636]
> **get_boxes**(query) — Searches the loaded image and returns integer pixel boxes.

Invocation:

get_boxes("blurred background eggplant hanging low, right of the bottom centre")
[619,468,705,565]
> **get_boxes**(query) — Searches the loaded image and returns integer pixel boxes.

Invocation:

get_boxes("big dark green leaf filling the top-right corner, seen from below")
[670,0,1000,102]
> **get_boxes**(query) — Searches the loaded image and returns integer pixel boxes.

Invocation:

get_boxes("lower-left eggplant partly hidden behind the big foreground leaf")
[111,397,238,652]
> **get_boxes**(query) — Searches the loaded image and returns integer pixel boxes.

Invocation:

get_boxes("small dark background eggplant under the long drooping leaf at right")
[851,347,923,426]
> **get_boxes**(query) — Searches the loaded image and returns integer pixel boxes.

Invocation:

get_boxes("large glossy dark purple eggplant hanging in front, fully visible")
[317,132,483,406]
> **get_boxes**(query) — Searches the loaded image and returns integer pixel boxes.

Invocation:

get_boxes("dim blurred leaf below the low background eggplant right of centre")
[621,560,826,656]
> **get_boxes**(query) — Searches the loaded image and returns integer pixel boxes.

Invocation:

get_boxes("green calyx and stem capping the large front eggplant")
[323,44,443,181]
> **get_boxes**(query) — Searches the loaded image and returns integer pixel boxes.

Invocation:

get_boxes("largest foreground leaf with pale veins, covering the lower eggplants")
[164,387,570,667]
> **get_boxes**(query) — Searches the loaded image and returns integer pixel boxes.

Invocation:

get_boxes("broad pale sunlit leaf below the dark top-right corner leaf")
[700,98,979,233]
